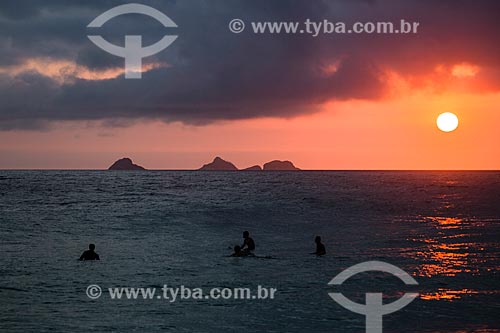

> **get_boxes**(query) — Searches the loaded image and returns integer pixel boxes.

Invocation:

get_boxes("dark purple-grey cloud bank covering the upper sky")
[0,0,500,129]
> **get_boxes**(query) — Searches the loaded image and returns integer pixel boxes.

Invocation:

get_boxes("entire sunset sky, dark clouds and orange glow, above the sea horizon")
[0,0,500,169]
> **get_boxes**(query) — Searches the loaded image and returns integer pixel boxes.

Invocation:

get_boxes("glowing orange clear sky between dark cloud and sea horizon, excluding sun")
[0,61,500,170]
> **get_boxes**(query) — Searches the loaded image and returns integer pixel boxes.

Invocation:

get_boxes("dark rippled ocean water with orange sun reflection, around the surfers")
[0,171,500,332]
